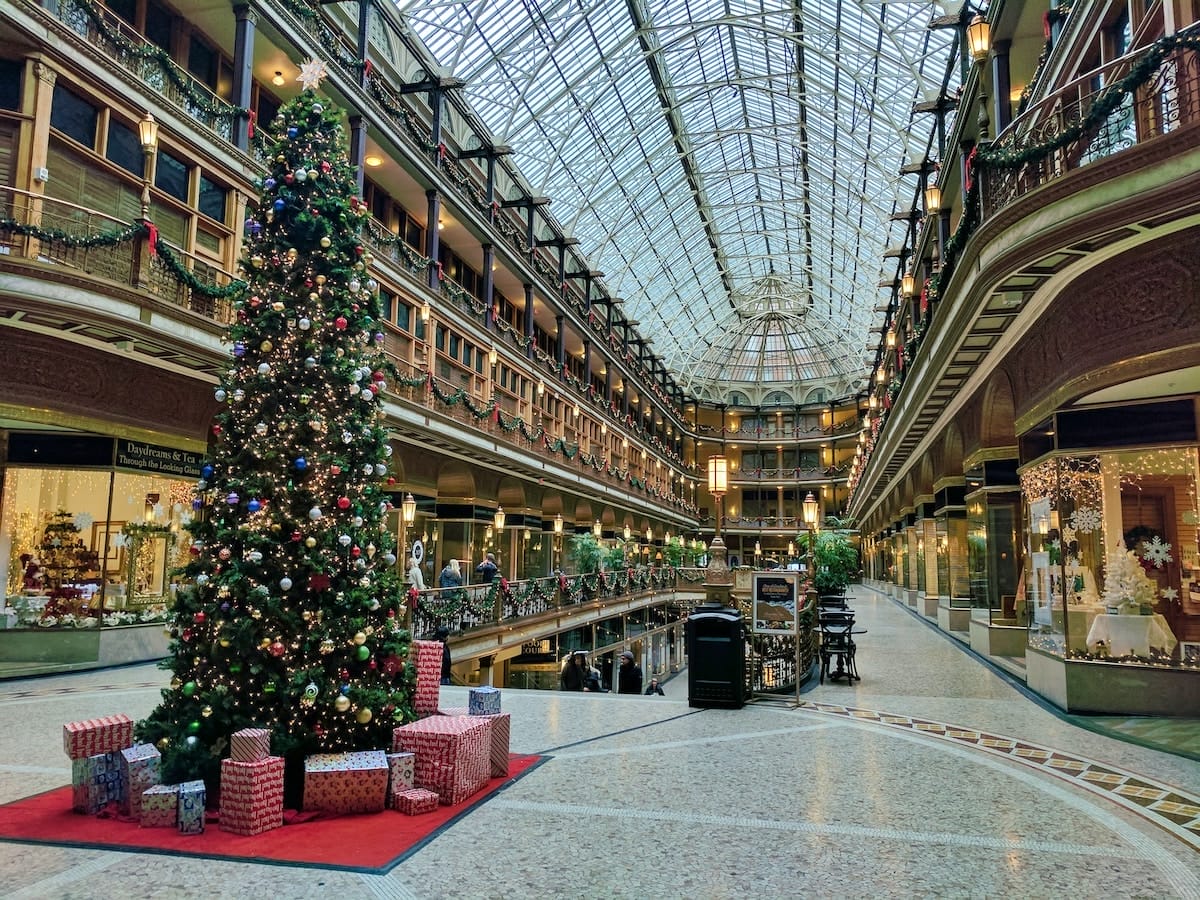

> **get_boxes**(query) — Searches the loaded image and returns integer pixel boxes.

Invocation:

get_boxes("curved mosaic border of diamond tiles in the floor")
[799,700,1200,852]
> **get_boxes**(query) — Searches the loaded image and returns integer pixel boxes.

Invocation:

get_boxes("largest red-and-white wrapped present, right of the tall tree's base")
[392,715,492,805]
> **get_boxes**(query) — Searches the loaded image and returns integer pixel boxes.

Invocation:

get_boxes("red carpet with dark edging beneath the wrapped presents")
[0,755,544,875]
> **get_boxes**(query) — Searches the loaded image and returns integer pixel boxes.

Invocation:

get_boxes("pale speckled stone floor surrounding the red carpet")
[0,588,1200,900]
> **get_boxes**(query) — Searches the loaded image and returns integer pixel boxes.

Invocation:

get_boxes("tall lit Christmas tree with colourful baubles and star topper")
[137,64,416,802]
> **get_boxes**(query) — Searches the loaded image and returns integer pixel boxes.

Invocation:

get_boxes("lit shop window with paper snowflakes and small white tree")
[1016,446,1200,667]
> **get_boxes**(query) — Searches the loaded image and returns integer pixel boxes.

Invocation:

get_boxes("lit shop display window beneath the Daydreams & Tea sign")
[0,467,193,628]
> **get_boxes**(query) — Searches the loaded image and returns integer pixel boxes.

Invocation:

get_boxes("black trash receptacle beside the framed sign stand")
[686,606,746,709]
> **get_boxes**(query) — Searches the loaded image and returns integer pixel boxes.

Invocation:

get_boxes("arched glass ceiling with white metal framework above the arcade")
[397,0,961,402]
